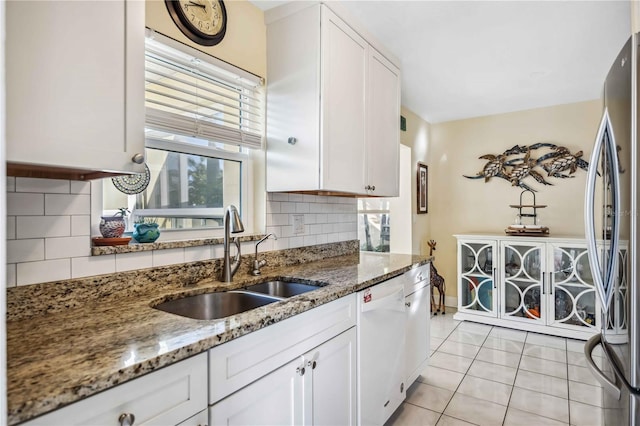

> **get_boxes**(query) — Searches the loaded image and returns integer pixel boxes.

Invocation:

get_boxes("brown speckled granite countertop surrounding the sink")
[7,248,429,425]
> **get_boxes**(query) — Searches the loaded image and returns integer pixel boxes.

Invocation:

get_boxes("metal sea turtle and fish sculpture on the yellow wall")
[463,142,589,191]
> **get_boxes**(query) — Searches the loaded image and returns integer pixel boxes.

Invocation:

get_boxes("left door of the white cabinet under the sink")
[209,357,305,426]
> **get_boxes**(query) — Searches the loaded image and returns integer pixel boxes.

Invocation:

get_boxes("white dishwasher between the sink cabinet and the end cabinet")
[357,275,406,425]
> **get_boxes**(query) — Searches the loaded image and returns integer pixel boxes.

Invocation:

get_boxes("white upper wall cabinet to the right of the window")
[266,3,400,196]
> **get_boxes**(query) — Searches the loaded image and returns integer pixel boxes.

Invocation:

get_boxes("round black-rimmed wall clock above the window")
[165,0,227,46]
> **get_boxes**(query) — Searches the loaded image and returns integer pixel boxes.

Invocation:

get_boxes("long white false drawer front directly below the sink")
[209,294,356,404]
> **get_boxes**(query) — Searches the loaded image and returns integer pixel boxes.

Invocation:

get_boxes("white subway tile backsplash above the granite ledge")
[7,177,358,287]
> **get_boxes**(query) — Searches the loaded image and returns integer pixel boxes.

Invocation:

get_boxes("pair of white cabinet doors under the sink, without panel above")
[209,327,356,425]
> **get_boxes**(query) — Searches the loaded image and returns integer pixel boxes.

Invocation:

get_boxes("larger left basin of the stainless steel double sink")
[154,291,282,320]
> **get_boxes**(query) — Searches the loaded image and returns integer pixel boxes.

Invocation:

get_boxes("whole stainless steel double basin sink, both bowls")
[154,280,319,320]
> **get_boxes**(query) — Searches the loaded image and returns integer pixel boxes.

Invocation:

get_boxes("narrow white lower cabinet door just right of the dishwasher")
[405,285,431,387]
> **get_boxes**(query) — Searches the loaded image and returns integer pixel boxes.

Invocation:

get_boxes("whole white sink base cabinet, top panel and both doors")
[209,294,356,425]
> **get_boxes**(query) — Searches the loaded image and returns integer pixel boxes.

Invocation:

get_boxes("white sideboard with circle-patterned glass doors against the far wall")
[454,235,626,339]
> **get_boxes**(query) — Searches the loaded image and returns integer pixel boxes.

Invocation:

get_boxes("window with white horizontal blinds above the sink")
[103,30,264,235]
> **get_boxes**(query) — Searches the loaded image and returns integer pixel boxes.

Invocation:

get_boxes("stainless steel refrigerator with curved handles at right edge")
[585,34,640,426]
